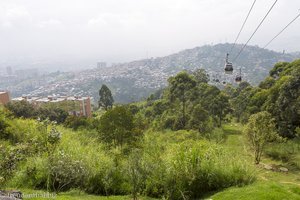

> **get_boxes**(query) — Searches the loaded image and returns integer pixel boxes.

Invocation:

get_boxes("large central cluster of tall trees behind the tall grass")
[140,70,231,134]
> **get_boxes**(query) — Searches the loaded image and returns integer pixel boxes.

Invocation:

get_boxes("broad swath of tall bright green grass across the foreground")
[3,122,255,199]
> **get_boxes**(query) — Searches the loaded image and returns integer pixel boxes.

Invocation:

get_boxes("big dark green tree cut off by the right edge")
[262,60,300,138]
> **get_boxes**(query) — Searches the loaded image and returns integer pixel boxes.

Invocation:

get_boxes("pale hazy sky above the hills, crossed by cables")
[0,0,300,65]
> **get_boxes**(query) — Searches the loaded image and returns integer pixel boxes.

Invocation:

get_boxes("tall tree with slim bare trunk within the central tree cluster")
[168,72,196,128]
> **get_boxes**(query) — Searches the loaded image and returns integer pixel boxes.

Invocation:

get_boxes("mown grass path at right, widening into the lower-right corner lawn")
[209,124,300,200]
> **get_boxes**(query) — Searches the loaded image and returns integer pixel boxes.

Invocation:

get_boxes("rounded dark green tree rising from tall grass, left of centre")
[99,106,141,148]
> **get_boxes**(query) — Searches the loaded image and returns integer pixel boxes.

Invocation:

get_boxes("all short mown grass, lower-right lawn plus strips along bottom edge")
[6,123,300,200]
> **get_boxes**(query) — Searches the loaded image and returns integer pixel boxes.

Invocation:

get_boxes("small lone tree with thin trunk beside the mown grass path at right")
[244,111,280,164]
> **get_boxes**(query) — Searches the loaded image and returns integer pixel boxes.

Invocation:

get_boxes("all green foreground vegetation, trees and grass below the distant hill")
[0,61,300,200]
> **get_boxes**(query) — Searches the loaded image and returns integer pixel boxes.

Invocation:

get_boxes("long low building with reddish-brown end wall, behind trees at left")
[12,96,92,117]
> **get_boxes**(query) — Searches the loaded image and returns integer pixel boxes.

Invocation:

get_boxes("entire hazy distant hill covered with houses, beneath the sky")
[5,43,300,102]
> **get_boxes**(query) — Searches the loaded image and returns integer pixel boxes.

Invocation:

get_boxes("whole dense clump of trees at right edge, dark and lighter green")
[231,60,300,138]
